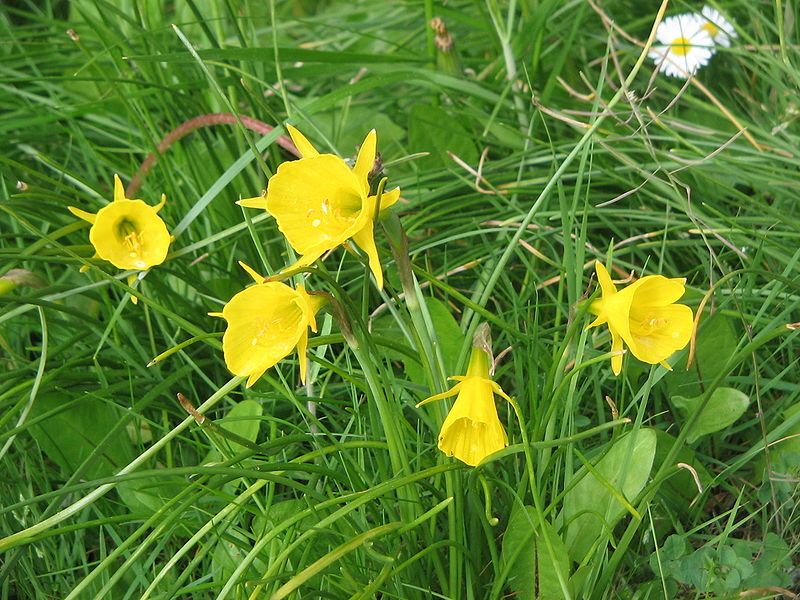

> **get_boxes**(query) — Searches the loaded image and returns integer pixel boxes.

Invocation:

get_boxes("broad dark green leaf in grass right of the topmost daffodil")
[408,104,478,168]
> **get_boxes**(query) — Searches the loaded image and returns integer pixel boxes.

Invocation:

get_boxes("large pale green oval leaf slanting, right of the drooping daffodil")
[561,429,656,562]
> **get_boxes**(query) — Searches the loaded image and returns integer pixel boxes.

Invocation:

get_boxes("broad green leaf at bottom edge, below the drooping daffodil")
[501,505,570,600]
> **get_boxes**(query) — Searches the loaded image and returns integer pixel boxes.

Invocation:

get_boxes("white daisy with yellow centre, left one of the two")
[650,13,714,79]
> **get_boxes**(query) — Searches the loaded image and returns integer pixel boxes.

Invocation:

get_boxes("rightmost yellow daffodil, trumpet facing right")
[587,261,694,375]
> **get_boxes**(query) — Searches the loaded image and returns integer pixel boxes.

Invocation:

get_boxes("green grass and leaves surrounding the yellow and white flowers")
[0,0,800,599]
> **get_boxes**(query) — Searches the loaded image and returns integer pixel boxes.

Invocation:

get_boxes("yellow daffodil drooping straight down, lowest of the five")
[417,328,511,467]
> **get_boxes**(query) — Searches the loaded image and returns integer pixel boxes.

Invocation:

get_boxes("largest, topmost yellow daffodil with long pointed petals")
[239,125,400,288]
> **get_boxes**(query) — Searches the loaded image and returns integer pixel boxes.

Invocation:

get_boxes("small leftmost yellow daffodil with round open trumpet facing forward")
[67,175,172,271]
